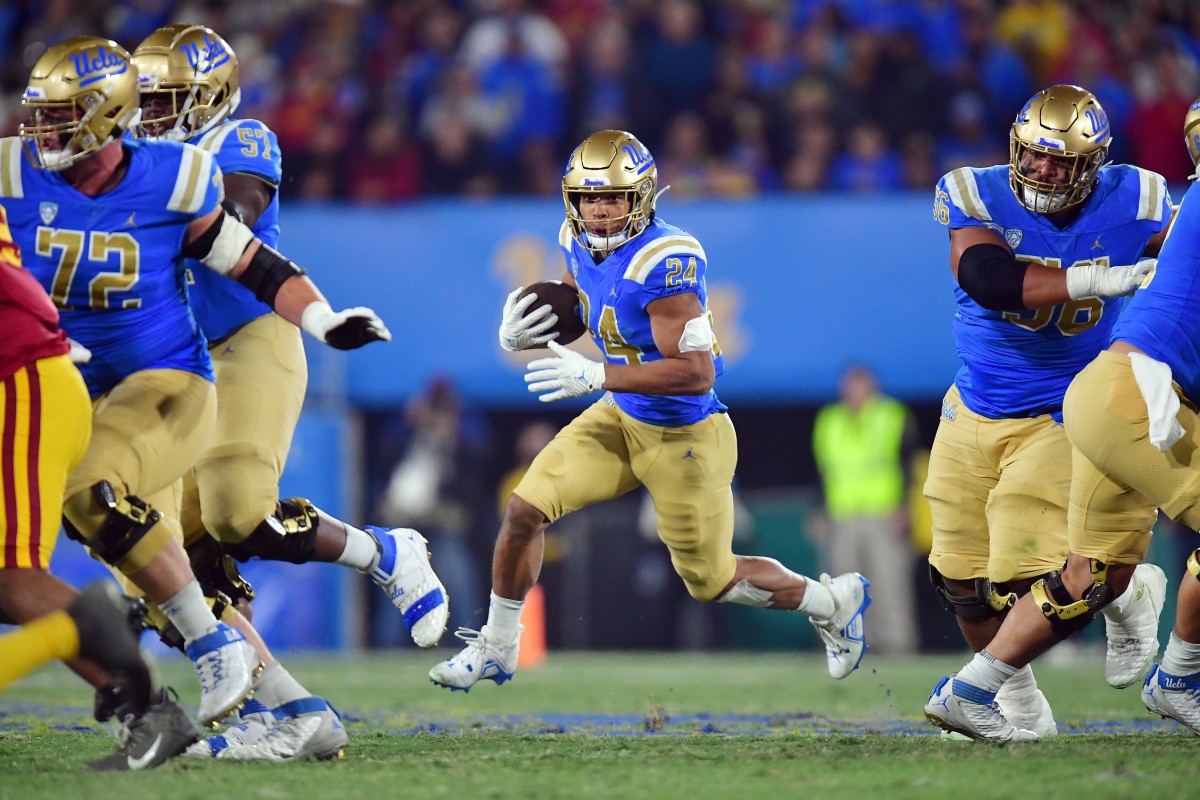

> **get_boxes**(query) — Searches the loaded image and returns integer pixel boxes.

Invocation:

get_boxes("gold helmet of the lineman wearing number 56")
[1008,84,1112,213]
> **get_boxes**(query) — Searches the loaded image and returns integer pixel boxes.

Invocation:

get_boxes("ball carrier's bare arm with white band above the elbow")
[602,291,716,395]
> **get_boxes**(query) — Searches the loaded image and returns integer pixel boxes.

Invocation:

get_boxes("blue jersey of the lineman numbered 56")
[934,164,1171,422]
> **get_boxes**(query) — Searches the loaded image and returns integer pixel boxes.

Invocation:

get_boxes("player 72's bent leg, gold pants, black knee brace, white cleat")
[64,369,258,723]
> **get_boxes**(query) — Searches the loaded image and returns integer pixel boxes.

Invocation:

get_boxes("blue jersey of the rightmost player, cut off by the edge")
[1112,184,1200,401]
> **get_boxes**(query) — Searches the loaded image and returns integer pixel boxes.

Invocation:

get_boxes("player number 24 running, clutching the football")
[430,131,870,690]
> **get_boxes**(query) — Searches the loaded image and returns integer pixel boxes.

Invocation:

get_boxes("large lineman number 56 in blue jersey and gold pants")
[925,85,1172,739]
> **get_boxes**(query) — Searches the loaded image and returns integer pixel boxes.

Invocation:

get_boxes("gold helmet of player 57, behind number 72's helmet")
[133,23,241,142]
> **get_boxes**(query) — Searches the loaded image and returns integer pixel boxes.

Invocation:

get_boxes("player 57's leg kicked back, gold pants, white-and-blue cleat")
[192,314,449,648]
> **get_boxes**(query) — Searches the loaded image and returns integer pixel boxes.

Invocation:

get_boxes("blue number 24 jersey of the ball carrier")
[558,219,727,427]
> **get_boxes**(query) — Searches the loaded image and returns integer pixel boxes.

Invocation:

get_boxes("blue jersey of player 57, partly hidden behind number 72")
[187,120,283,341]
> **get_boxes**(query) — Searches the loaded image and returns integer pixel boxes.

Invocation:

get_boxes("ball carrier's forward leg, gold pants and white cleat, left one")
[430,397,637,691]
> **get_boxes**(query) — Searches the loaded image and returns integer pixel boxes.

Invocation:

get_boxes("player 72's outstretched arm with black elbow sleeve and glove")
[184,206,391,350]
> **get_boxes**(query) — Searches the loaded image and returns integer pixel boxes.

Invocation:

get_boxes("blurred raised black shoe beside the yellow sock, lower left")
[67,581,152,714]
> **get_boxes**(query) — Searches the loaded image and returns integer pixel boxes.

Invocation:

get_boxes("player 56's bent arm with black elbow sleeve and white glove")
[950,225,1150,311]
